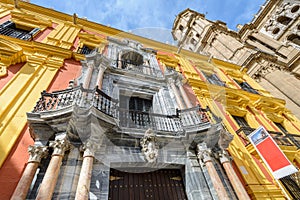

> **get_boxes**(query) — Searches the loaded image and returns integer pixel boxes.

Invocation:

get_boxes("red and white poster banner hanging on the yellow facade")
[248,126,297,179]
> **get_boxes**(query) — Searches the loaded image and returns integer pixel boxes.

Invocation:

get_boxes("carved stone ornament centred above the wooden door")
[140,129,158,163]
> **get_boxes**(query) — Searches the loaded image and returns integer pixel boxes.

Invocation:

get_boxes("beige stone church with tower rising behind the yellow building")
[172,0,300,118]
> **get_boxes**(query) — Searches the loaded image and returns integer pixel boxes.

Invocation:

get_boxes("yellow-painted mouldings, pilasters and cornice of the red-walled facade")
[0,0,300,199]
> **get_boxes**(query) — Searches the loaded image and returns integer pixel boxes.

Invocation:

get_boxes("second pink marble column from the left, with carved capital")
[36,138,69,200]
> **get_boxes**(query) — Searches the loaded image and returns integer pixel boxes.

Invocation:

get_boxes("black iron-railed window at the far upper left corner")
[0,21,40,40]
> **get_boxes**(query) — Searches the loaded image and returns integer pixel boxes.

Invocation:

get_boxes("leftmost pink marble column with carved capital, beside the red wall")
[11,145,48,200]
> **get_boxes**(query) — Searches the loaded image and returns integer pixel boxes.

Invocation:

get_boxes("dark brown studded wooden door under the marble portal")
[108,169,187,200]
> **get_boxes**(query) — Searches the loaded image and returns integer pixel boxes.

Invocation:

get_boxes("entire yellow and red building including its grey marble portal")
[0,1,300,200]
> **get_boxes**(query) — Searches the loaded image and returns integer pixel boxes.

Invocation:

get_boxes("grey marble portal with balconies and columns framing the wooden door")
[19,38,241,199]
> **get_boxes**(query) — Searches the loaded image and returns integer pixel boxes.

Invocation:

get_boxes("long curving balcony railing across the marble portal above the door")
[32,85,209,135]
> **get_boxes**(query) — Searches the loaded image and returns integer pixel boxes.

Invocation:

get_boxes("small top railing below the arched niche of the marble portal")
[114,60,162,77]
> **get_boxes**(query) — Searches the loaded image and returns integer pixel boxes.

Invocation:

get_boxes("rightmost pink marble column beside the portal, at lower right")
[220,151,250,200]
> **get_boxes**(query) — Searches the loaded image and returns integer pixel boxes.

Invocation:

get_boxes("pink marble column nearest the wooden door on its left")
[75,140,97,200]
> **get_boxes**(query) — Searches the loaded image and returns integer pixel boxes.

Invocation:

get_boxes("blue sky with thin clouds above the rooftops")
[30,0,265,44]
